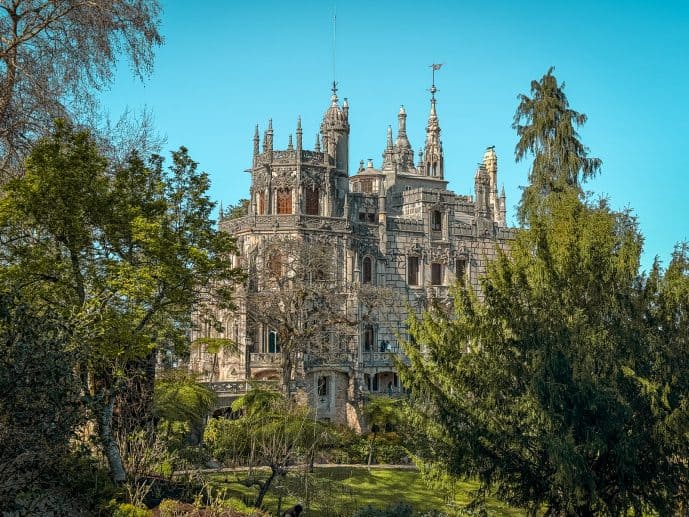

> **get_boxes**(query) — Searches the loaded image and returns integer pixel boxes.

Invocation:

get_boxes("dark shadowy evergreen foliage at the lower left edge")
[0,289,88,515]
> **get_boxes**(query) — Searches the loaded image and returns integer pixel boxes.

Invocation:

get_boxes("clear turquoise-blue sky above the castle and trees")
[103,0,689,267]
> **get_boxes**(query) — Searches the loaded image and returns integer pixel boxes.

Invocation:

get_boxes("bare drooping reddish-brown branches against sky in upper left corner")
[0,0,163,182]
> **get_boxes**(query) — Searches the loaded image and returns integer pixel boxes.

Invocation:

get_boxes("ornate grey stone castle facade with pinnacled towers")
[190,81,513,428]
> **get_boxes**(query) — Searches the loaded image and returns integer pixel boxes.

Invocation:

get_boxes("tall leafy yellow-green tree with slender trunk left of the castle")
[0,124,241,482]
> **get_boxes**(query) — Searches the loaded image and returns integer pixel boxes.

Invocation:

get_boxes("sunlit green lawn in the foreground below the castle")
[210,467,524,517]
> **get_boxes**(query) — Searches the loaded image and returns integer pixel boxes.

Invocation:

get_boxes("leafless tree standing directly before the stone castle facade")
[246,235,391,389]
